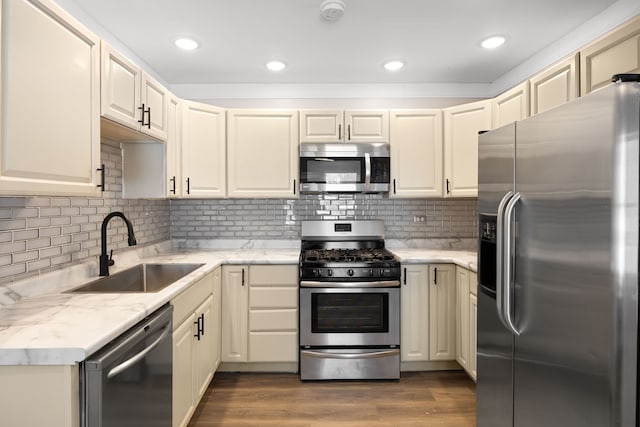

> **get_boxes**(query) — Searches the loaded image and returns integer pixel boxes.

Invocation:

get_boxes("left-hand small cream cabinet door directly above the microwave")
[300,110,344,142]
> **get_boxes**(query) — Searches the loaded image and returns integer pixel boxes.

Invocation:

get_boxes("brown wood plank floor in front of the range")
[189,371,476,427]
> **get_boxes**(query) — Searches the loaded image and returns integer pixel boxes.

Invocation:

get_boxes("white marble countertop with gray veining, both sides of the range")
[0,245,476,365]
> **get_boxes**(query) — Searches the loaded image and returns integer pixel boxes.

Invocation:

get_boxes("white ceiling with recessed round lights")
[60,0,632,98]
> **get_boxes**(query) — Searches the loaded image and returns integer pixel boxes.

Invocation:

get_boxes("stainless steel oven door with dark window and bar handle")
[300,284,400,347]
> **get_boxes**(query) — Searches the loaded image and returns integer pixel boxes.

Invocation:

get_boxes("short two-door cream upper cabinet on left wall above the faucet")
[101,41,170,141]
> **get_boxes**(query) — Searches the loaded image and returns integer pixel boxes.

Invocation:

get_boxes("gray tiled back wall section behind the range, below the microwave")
[171,194,478,244]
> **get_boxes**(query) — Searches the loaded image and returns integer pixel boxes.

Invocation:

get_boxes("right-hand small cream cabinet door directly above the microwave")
[344,110,389,143]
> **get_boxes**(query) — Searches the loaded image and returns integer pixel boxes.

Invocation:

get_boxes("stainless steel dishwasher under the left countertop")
[80,304,173,427]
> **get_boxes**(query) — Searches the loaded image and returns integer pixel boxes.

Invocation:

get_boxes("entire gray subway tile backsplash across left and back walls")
[0,144,477,283]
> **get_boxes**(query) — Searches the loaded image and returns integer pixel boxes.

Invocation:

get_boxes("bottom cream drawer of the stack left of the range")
[249,332,298,362]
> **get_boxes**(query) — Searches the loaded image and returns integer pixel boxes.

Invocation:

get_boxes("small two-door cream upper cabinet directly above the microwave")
[300,110,389,143]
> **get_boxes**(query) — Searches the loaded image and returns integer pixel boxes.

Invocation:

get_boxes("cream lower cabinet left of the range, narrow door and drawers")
[222,265,298,363]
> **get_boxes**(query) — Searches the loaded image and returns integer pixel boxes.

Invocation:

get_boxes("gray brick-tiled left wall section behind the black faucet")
[0,144,170,283]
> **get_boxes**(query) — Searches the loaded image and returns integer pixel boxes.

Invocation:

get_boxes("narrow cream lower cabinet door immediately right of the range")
[400,264,430,362]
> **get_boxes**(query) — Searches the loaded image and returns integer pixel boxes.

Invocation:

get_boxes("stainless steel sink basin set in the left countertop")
[67,264,204,293]
